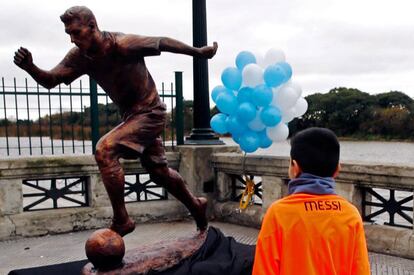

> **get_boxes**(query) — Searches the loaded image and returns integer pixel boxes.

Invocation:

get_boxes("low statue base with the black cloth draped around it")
[9,226,255,275]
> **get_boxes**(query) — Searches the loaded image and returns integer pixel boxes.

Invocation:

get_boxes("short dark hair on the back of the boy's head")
[290,127,339,177]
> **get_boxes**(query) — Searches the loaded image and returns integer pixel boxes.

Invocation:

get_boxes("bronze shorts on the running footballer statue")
[97,106,167,167]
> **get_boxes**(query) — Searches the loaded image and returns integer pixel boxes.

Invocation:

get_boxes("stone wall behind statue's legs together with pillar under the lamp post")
[0,146,238,240]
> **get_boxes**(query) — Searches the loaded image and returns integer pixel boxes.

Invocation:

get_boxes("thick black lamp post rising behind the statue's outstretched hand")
[185,0,223,145]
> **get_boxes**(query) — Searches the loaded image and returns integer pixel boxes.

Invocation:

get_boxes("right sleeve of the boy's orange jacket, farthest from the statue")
[352,220,371,275]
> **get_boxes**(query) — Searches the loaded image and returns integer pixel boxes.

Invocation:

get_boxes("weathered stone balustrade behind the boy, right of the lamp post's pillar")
[212,154,414,259]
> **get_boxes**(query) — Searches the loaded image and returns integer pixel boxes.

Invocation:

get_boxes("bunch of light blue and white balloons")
[210,49,308,153]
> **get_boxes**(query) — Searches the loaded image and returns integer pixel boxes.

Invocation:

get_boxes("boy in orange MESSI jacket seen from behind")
[253,128,370,275]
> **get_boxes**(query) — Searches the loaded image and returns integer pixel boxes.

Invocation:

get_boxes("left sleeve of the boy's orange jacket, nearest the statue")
[252,208,280,275]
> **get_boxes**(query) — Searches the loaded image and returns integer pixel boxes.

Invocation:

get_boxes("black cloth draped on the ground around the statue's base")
[9,226,255,275]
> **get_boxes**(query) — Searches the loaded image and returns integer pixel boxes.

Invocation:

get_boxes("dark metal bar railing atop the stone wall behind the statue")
[0,72,184,157]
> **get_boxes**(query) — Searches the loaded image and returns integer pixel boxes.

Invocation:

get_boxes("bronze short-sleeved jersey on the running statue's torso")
[61,32,164,119]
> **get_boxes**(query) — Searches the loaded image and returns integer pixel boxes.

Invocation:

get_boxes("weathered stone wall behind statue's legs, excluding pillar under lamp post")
[0,153,187,240]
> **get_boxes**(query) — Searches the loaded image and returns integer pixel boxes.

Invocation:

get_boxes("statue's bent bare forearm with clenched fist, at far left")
[14,47,81,89]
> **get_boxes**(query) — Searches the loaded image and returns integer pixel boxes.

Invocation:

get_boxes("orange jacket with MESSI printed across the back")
[253,193,370,275]
